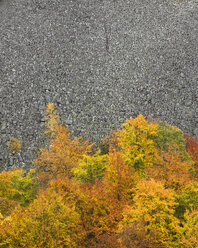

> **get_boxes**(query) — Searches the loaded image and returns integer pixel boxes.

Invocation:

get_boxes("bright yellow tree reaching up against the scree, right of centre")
[115,115,158,174]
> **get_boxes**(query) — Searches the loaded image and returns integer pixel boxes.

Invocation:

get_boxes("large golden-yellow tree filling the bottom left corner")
[0,190,85,248]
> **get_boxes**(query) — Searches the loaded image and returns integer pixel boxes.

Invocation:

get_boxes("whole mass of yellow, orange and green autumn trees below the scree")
[3,103,198,248]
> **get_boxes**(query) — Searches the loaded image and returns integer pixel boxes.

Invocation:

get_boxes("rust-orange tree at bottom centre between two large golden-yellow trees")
[81,181,123,247]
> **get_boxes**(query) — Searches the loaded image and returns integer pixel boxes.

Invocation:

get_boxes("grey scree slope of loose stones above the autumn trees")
[0,0,198,169]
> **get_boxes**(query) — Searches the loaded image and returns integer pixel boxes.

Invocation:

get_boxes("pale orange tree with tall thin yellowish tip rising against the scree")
[34,101,92,184]
